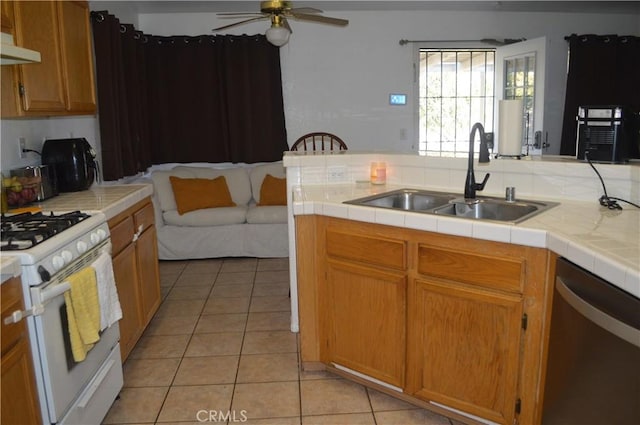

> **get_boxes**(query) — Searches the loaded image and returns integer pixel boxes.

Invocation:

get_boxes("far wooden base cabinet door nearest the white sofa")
[136,226,161,326]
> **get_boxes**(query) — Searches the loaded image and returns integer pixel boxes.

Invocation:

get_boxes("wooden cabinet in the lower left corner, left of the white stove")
[0,278,42,424]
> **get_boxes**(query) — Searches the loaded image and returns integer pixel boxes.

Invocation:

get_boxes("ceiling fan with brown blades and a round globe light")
[212,0,349,46]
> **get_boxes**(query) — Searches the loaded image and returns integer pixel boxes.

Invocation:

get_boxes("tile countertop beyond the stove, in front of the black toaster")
[28,184,153,220]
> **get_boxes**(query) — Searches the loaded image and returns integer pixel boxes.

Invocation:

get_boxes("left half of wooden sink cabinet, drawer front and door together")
[321,226,407,388]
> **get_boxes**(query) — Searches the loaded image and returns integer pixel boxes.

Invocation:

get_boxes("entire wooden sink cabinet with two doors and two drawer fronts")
[296,216,552,424]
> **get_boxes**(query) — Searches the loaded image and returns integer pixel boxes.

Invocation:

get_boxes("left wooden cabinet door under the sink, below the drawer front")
[326,261,407,388]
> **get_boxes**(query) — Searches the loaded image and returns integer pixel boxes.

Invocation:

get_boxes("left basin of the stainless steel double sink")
[345,189,457,211]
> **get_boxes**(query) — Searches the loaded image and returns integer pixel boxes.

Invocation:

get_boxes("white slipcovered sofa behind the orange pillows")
[151,162,289,260]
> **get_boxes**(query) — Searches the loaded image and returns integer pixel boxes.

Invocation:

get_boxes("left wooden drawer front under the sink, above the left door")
[327,229,407,270]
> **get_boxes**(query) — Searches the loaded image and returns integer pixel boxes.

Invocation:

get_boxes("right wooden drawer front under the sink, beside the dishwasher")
[418,245,525,292]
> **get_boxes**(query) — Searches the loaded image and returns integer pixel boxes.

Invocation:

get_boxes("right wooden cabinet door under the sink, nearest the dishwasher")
[407,280,522,424]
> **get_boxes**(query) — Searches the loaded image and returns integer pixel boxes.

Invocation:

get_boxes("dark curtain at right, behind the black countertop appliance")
[560,34,640,155]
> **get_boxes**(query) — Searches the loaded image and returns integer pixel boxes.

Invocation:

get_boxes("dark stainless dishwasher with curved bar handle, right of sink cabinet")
[542,258,640,425]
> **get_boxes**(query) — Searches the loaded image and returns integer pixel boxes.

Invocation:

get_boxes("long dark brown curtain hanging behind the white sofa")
[92,12,288,180]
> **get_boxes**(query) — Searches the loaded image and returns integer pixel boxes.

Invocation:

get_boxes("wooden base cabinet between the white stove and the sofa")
[109,198,161,361]
